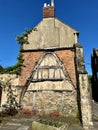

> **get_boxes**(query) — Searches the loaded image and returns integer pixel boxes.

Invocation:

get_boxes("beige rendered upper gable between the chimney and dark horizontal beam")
[23,18,77,50]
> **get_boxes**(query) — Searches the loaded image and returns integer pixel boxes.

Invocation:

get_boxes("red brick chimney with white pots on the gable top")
[43,3,55,18]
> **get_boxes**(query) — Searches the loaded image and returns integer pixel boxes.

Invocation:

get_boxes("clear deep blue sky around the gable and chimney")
[0,0,98,74]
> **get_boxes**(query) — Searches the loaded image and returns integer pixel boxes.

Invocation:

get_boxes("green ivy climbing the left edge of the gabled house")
[0,28,37,75]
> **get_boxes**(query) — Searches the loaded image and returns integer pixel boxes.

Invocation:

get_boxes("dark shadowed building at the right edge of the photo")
[91,49,98,102]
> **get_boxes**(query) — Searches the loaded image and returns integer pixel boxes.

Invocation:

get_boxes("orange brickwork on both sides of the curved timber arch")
[19,50,76,86]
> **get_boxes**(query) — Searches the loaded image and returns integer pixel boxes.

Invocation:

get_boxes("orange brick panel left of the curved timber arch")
[19,52,43,86]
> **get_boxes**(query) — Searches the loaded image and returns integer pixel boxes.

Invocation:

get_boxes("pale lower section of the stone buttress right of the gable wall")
[79,74,93,129]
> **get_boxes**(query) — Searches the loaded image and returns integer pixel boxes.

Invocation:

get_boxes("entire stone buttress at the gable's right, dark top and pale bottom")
[75,43,93,129]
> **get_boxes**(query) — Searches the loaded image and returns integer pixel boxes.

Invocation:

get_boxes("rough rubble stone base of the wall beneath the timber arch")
[22,90,78,118]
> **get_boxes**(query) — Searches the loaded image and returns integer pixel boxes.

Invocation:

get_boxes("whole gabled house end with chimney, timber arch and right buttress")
[0,1,93,129]
